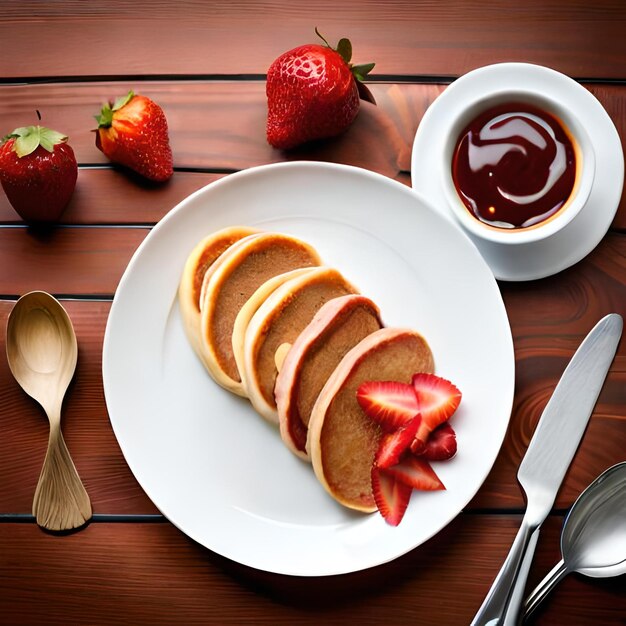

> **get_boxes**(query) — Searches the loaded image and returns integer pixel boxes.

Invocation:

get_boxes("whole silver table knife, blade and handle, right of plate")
[471,313,623,626]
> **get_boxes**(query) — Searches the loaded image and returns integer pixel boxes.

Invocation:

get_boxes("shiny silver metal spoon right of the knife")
[524,461,626,619]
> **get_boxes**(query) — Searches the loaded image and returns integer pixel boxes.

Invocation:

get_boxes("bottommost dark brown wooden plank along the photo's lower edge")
[0,515,626,626]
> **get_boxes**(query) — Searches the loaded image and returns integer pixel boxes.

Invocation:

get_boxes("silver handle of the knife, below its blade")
[471,515,538,626]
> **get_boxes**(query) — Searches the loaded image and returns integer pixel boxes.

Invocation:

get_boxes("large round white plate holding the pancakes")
[103,163,514,576]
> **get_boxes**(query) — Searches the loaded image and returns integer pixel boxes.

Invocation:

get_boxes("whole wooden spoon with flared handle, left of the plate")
[6,291,91,530]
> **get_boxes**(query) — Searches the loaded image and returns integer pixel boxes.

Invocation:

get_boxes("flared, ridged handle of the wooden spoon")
[33,420,91,530]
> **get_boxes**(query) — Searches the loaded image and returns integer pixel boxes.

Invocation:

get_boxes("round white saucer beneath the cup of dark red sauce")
[411,63,624,281]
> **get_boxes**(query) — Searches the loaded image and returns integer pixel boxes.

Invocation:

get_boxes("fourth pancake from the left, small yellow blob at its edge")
[243,267,356,424]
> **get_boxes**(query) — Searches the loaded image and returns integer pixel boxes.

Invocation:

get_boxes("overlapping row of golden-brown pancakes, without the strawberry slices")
[179,226,434,512]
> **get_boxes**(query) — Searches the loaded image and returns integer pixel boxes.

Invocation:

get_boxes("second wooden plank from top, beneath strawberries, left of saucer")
[0,82,428,182]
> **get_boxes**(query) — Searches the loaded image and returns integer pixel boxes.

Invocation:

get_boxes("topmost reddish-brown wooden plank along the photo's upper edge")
[0,0,626,78]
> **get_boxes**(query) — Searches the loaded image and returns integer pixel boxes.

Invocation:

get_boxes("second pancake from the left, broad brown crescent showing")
[200,233,321,396]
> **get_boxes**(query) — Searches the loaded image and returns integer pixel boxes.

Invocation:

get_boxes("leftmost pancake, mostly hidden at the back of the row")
[178,226,258,366]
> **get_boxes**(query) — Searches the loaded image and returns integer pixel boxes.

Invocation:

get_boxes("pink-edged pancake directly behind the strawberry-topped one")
[275,294,382,460]
